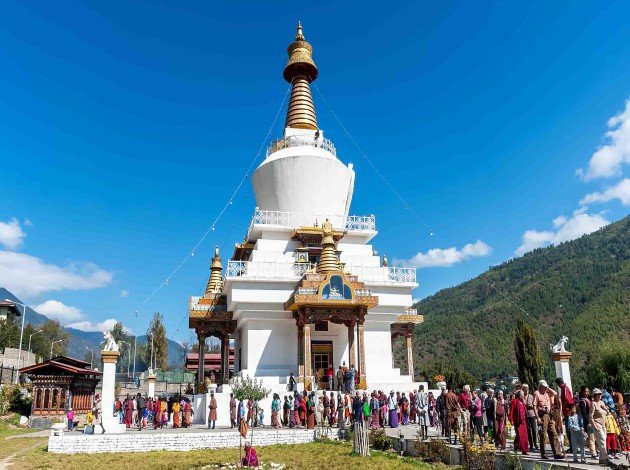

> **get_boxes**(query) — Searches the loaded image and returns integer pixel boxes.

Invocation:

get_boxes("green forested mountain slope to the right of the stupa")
[404,216,630,384]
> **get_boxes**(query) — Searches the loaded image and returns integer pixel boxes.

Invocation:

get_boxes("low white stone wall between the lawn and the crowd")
[48,428,346,454]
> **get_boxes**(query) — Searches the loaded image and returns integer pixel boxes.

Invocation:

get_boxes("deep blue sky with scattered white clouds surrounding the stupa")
[0,1,630,340]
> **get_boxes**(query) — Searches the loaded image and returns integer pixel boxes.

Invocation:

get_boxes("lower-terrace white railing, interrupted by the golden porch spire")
[226,261,416,282]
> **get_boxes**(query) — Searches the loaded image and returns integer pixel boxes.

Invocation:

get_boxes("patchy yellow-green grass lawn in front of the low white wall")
[3,439,446,470]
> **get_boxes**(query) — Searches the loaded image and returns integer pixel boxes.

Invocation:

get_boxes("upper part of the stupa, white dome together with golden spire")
[253,23,354,217]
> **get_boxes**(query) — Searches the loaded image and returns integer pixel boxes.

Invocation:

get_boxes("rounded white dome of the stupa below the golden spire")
[253,138,354,216]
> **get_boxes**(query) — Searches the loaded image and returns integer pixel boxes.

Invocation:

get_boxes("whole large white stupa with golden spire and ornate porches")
[190,24,422,420]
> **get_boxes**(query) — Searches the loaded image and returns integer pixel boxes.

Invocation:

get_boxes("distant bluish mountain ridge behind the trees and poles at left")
[0,287,183,367]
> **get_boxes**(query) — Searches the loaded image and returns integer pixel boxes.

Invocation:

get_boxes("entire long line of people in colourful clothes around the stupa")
[84,363,630,464]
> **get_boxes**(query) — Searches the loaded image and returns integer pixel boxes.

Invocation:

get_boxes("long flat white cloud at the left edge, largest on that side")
[0,250,113,297]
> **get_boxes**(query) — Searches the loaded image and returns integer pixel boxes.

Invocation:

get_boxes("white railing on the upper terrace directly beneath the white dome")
[250,209,376,232]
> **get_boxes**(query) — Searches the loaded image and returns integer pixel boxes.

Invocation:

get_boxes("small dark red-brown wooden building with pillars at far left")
[20,356,103,417]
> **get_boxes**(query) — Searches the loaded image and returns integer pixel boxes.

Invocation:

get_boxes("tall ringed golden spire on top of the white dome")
[283,21,318,130]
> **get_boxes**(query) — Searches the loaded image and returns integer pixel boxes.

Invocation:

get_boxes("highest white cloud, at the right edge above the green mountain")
[577,99,630,181]
